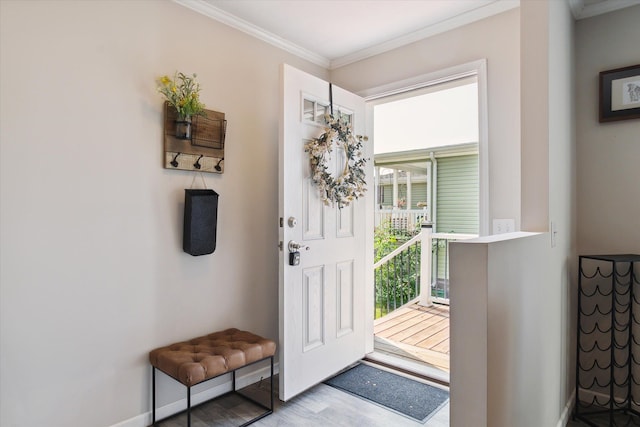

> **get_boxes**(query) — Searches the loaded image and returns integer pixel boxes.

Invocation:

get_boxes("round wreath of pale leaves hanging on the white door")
[304,114,367,209]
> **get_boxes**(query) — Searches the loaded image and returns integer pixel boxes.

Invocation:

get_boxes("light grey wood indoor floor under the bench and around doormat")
[156,376,449,427]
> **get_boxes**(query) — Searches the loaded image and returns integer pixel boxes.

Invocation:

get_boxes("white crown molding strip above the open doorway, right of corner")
[329,0,520,70]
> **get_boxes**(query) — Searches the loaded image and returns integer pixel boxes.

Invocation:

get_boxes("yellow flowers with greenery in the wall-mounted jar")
[158,71,205,120]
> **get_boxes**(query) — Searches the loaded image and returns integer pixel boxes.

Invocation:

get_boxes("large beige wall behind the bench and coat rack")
[0,0,328,427]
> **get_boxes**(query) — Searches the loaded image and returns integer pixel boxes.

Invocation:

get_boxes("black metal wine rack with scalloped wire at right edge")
[573,254,640,427]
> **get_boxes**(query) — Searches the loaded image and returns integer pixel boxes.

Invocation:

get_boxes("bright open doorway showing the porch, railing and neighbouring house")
[367,70,486,384]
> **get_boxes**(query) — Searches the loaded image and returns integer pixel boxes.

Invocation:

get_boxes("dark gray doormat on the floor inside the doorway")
[325,364,449,423]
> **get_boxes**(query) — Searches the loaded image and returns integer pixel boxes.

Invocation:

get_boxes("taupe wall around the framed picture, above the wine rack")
[575,6,640,255]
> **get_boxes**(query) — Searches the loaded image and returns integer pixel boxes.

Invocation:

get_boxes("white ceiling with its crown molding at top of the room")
[174,0,640,68]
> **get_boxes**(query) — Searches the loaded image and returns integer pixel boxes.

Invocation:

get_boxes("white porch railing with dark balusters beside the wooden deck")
[374,227,477,318]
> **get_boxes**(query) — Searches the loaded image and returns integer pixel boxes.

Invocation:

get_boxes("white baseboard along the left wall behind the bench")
[110,362,279,427]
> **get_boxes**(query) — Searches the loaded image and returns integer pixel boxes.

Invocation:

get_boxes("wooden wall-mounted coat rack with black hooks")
[164,102,227,173]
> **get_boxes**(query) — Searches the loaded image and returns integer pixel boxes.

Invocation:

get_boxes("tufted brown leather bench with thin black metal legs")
[149,329,276,426]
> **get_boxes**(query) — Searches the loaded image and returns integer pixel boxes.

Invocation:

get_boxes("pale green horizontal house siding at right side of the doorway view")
[436,154,480,234]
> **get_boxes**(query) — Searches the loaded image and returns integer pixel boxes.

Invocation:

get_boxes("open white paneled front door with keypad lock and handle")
[279,65,373,401]
